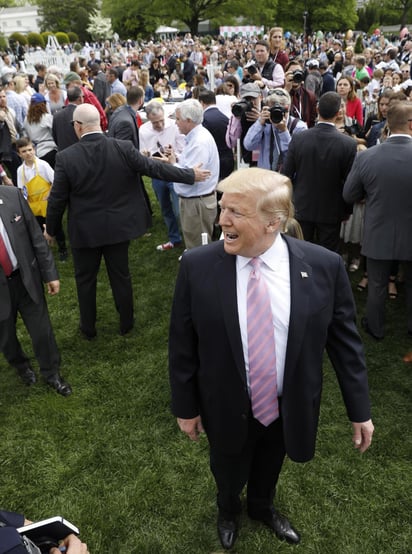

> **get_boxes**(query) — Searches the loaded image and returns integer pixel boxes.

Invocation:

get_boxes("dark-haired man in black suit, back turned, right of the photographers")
[282,92,356,252]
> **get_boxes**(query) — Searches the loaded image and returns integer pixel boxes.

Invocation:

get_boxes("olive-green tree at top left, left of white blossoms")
[37,0,97,41]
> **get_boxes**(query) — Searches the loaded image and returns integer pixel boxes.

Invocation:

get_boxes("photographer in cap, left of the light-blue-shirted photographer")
[226,83,262,167]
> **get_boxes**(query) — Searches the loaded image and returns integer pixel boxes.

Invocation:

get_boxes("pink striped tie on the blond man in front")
[247,258,279,427]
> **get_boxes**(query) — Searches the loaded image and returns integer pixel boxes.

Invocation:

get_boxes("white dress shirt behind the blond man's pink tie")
[236,234,290,396]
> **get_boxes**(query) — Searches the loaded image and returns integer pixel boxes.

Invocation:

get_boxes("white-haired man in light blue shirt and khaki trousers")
[168,99,219,249]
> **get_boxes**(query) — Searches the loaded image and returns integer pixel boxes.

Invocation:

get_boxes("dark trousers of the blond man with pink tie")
[210,408,285,519]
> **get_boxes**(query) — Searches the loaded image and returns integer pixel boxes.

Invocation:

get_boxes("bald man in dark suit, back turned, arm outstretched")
[46,104,209,339]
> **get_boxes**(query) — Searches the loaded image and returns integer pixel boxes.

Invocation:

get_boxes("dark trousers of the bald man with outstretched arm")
[72,241,133,335]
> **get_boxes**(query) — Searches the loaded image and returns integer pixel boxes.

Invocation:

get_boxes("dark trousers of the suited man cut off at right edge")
[366,258,412,337]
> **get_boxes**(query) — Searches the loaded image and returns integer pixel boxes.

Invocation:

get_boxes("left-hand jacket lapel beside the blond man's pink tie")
[216,252,247,385]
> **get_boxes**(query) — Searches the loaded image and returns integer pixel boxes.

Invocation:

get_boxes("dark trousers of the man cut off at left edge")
[0,274,60,380]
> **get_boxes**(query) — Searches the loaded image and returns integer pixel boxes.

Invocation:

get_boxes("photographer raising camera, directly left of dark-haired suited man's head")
[285,60,317,127]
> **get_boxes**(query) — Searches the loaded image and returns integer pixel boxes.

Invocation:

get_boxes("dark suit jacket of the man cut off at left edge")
[0,185,59,319]
